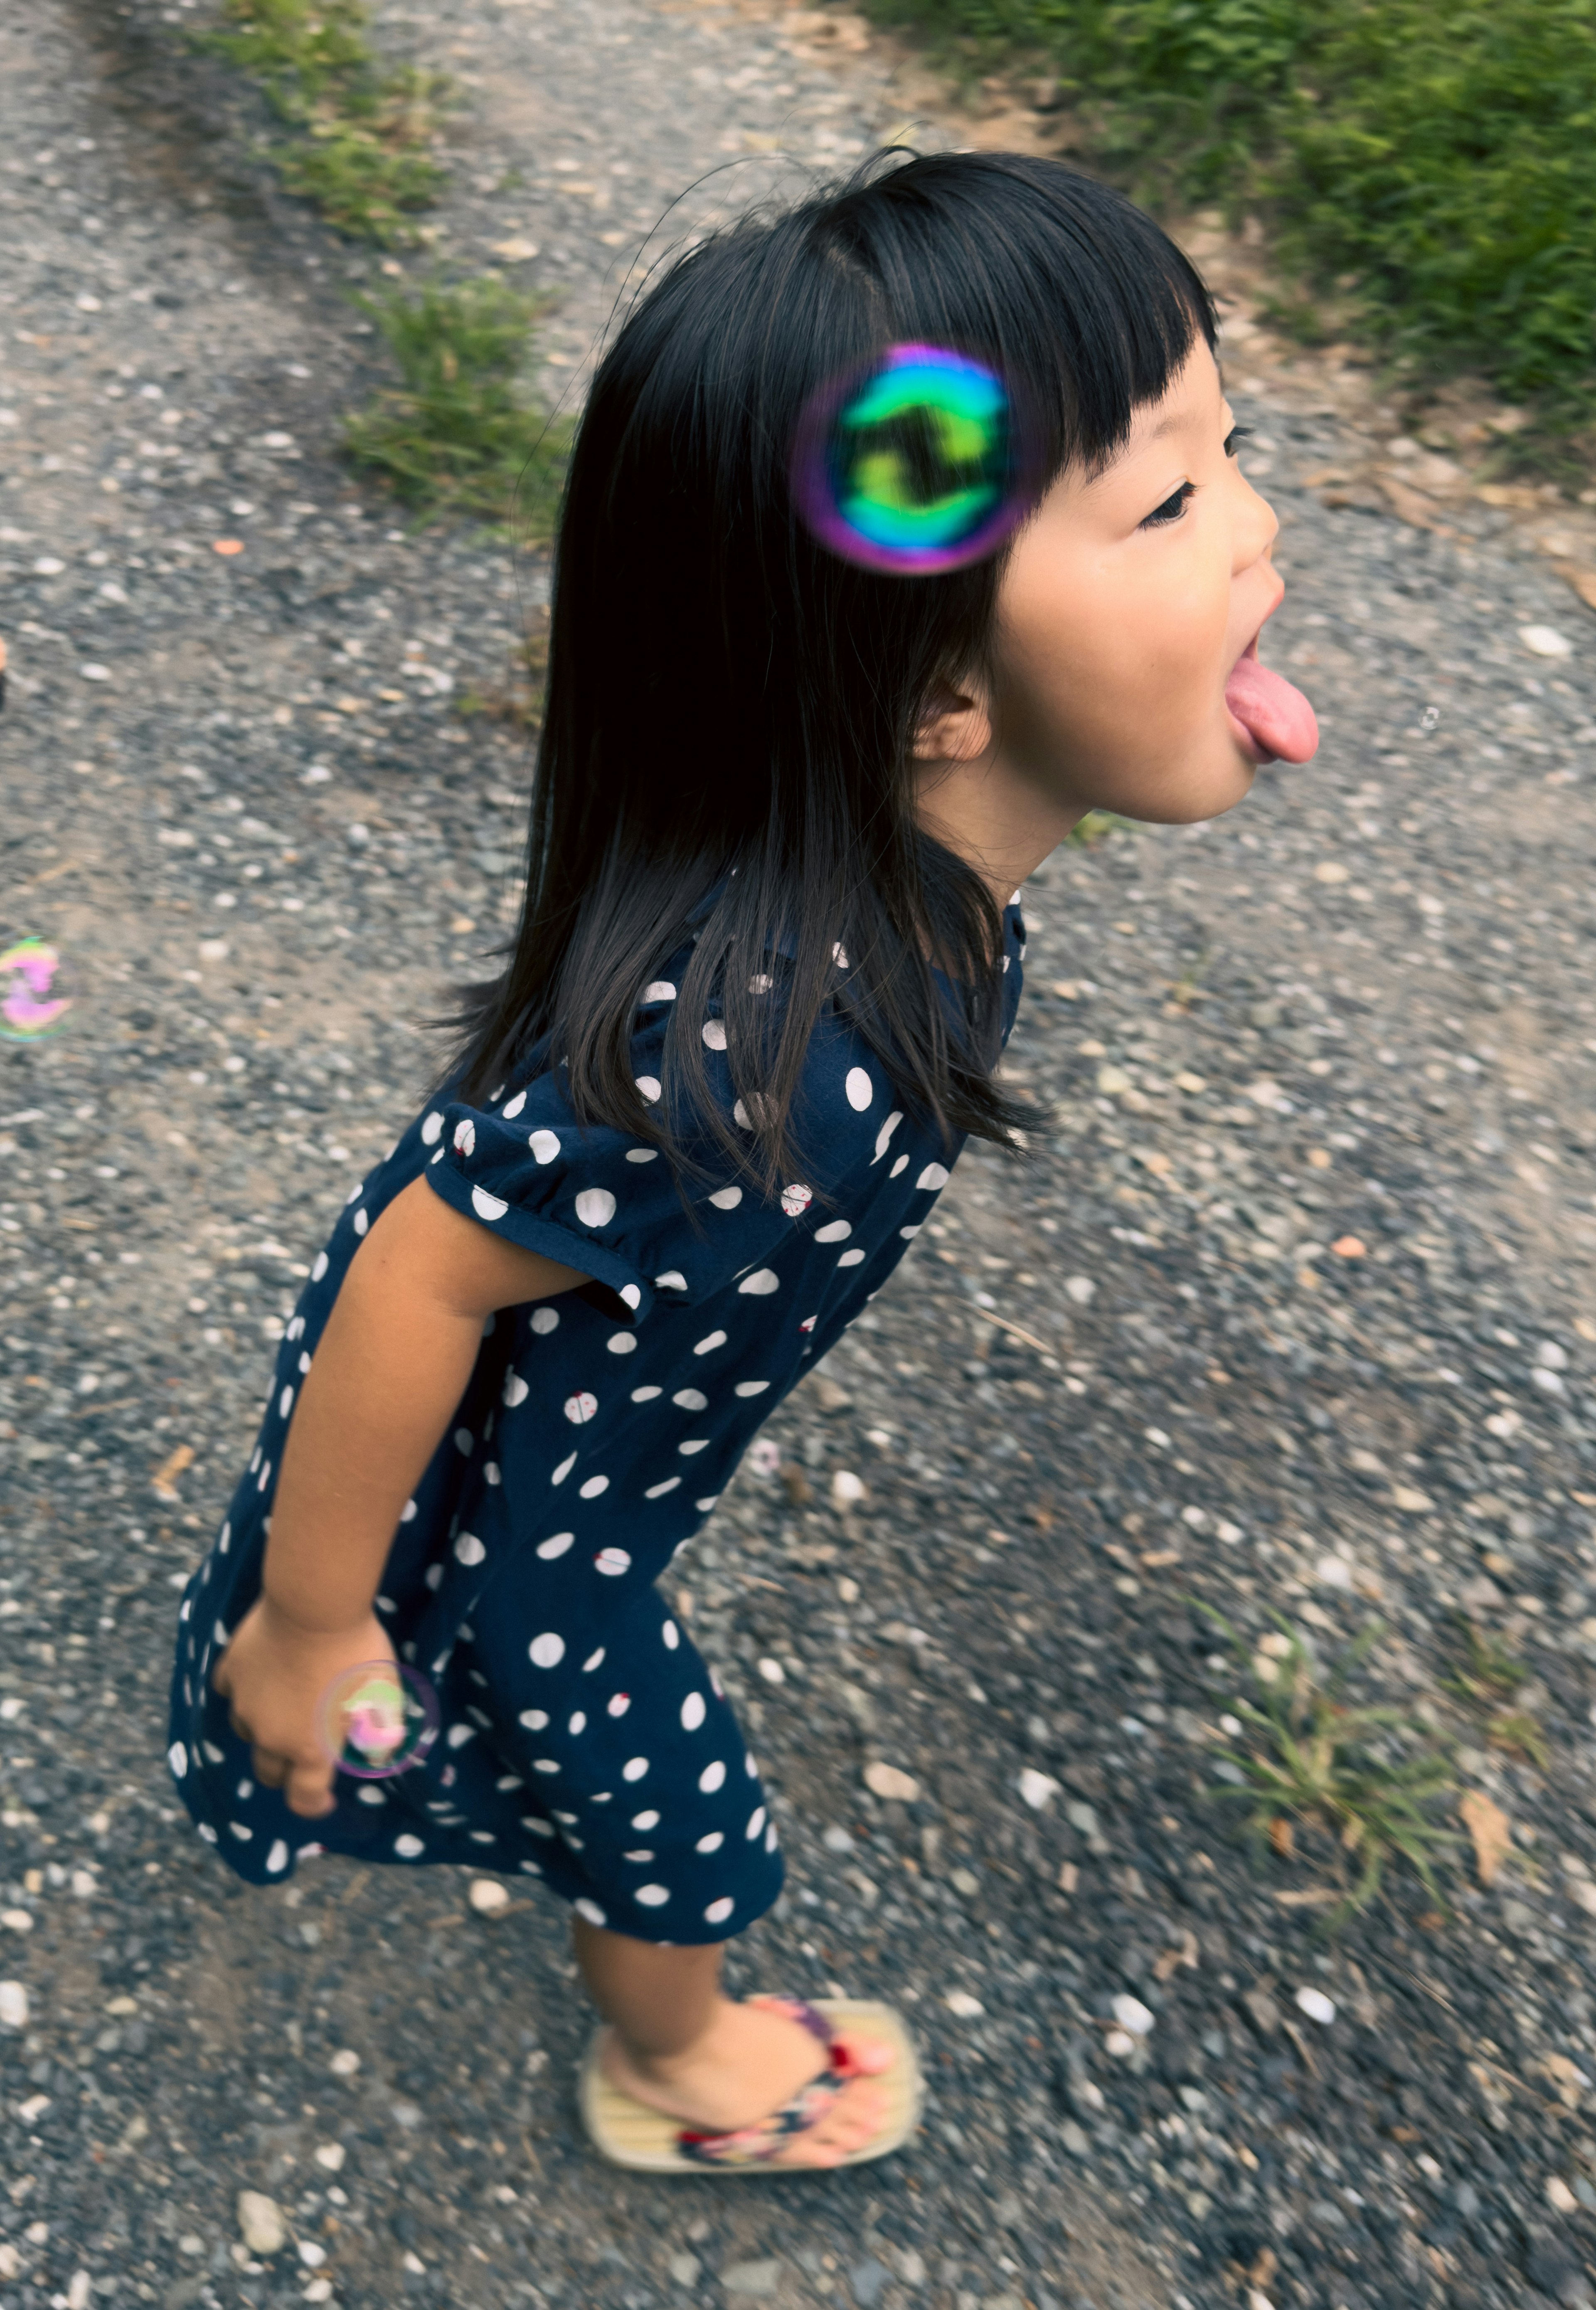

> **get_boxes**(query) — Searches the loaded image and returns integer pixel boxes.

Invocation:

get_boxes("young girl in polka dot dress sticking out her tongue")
[171,153,1317,2167]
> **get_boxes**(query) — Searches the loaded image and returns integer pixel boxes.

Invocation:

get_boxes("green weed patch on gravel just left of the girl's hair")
[344,275,571,538]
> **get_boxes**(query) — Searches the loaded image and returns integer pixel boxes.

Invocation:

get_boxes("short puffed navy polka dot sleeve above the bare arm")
[420,1021,790,1321]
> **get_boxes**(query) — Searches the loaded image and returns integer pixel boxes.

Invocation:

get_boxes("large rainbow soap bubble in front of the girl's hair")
[792,344,1028,578]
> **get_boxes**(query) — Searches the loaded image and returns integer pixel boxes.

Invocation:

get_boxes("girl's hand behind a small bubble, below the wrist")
[210,1596,395,1820]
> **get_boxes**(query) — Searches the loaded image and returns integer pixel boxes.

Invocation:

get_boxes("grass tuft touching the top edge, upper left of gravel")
[199,0,448,247]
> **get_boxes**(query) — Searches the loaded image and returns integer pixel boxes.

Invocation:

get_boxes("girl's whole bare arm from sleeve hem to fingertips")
[215,1178,587,1816]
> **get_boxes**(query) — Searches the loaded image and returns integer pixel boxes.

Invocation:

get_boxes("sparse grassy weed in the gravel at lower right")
[1199,1603,1455,1933]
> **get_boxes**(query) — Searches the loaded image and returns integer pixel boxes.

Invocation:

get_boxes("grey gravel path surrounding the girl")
[0,0,1596,2310]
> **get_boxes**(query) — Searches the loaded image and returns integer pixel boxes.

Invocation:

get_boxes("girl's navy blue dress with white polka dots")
[169,894,1023,1943]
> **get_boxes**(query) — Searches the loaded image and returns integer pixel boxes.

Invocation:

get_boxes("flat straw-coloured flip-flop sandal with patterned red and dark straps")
[577,1996,924,2174]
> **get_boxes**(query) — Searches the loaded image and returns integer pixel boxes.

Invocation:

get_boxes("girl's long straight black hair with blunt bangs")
[443,153,1215,1180]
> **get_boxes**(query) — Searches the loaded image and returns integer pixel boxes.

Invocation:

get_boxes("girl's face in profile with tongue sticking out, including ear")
[919,340,1317,896]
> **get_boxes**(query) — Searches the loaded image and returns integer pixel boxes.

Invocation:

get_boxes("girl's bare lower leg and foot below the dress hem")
[573,1917,892,2165]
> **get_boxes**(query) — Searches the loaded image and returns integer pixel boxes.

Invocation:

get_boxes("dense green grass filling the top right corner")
[866,0,1596,432]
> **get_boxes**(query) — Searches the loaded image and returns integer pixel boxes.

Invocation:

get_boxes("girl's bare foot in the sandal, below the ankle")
[601,1998,894,2167]
